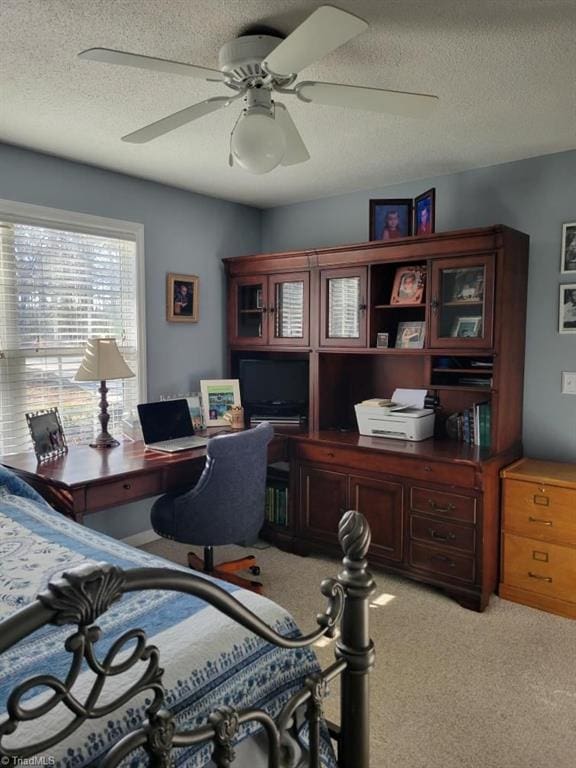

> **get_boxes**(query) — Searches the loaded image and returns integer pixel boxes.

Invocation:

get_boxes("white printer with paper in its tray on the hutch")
[354,389,434,441]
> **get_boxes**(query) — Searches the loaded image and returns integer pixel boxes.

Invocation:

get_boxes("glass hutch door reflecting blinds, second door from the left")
[269,272,310,346]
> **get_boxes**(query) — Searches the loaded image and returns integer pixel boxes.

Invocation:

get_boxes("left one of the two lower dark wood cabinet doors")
[297,464,348,543]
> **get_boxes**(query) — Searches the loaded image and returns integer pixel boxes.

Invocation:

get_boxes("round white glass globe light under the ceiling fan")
[231,107,286,174]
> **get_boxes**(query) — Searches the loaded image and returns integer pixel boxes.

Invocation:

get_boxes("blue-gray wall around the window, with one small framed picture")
[0,144,261,537]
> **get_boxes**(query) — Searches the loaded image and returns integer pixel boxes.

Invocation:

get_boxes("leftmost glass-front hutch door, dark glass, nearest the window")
[228,276,268,347]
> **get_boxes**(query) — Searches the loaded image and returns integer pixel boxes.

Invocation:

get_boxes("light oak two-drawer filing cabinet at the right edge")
[499,459,576,619]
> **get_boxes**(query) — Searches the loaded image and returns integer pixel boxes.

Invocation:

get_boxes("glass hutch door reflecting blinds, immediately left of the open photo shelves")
[320,267,367,347]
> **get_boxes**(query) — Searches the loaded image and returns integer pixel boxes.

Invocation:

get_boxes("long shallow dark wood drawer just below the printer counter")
[294,440,475,488]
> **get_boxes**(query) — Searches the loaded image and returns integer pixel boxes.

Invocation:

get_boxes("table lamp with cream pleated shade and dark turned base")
[74,339,134,449]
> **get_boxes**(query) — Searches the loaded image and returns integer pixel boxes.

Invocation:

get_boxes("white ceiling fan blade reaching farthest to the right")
[295,82,439,117]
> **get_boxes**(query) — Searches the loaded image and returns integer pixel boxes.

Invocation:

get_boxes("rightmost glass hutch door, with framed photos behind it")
[431,256,494,347]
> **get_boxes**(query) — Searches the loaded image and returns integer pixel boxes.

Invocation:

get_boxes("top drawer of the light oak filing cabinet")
[503,480,576,544]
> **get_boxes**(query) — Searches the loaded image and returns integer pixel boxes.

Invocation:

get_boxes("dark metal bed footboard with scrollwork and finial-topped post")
[0,511,375,768]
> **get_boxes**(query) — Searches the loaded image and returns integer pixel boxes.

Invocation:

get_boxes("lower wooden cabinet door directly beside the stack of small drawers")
[349,475,404,562]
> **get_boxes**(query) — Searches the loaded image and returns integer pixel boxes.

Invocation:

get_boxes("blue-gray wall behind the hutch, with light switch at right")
[262,151,576,461]
